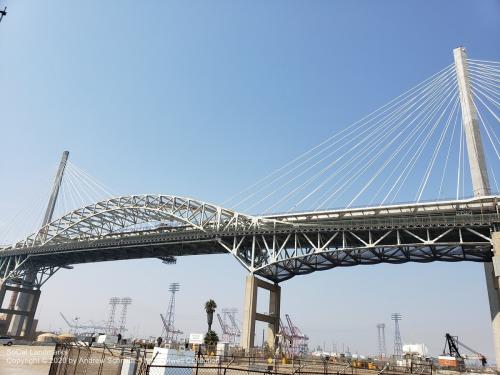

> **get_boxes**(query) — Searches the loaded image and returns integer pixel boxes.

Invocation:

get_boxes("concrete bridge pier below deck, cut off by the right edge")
[484,232,500,373]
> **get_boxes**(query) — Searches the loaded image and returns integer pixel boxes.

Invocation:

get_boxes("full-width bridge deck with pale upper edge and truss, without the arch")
[0,196,500,281]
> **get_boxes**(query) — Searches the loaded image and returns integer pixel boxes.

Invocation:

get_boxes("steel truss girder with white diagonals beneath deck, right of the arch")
[219,227,492,282]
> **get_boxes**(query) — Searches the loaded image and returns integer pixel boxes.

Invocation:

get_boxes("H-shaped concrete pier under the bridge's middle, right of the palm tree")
[241,275,281,352]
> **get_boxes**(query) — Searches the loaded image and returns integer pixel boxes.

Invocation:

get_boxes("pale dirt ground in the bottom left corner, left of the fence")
[0,345,54,375]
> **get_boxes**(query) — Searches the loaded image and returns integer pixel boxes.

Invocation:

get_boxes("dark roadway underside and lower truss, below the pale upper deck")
[5,224,492,282]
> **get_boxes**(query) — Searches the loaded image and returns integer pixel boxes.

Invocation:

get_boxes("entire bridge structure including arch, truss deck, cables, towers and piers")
[0,48,500,363]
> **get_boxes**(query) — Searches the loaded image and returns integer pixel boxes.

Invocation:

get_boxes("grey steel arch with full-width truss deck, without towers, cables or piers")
[0,195,500,287]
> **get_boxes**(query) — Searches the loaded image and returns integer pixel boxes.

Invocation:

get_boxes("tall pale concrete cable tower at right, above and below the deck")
[453,47,500,372]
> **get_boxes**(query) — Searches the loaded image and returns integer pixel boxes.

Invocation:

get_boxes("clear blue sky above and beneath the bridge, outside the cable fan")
[0,0,500,357]
